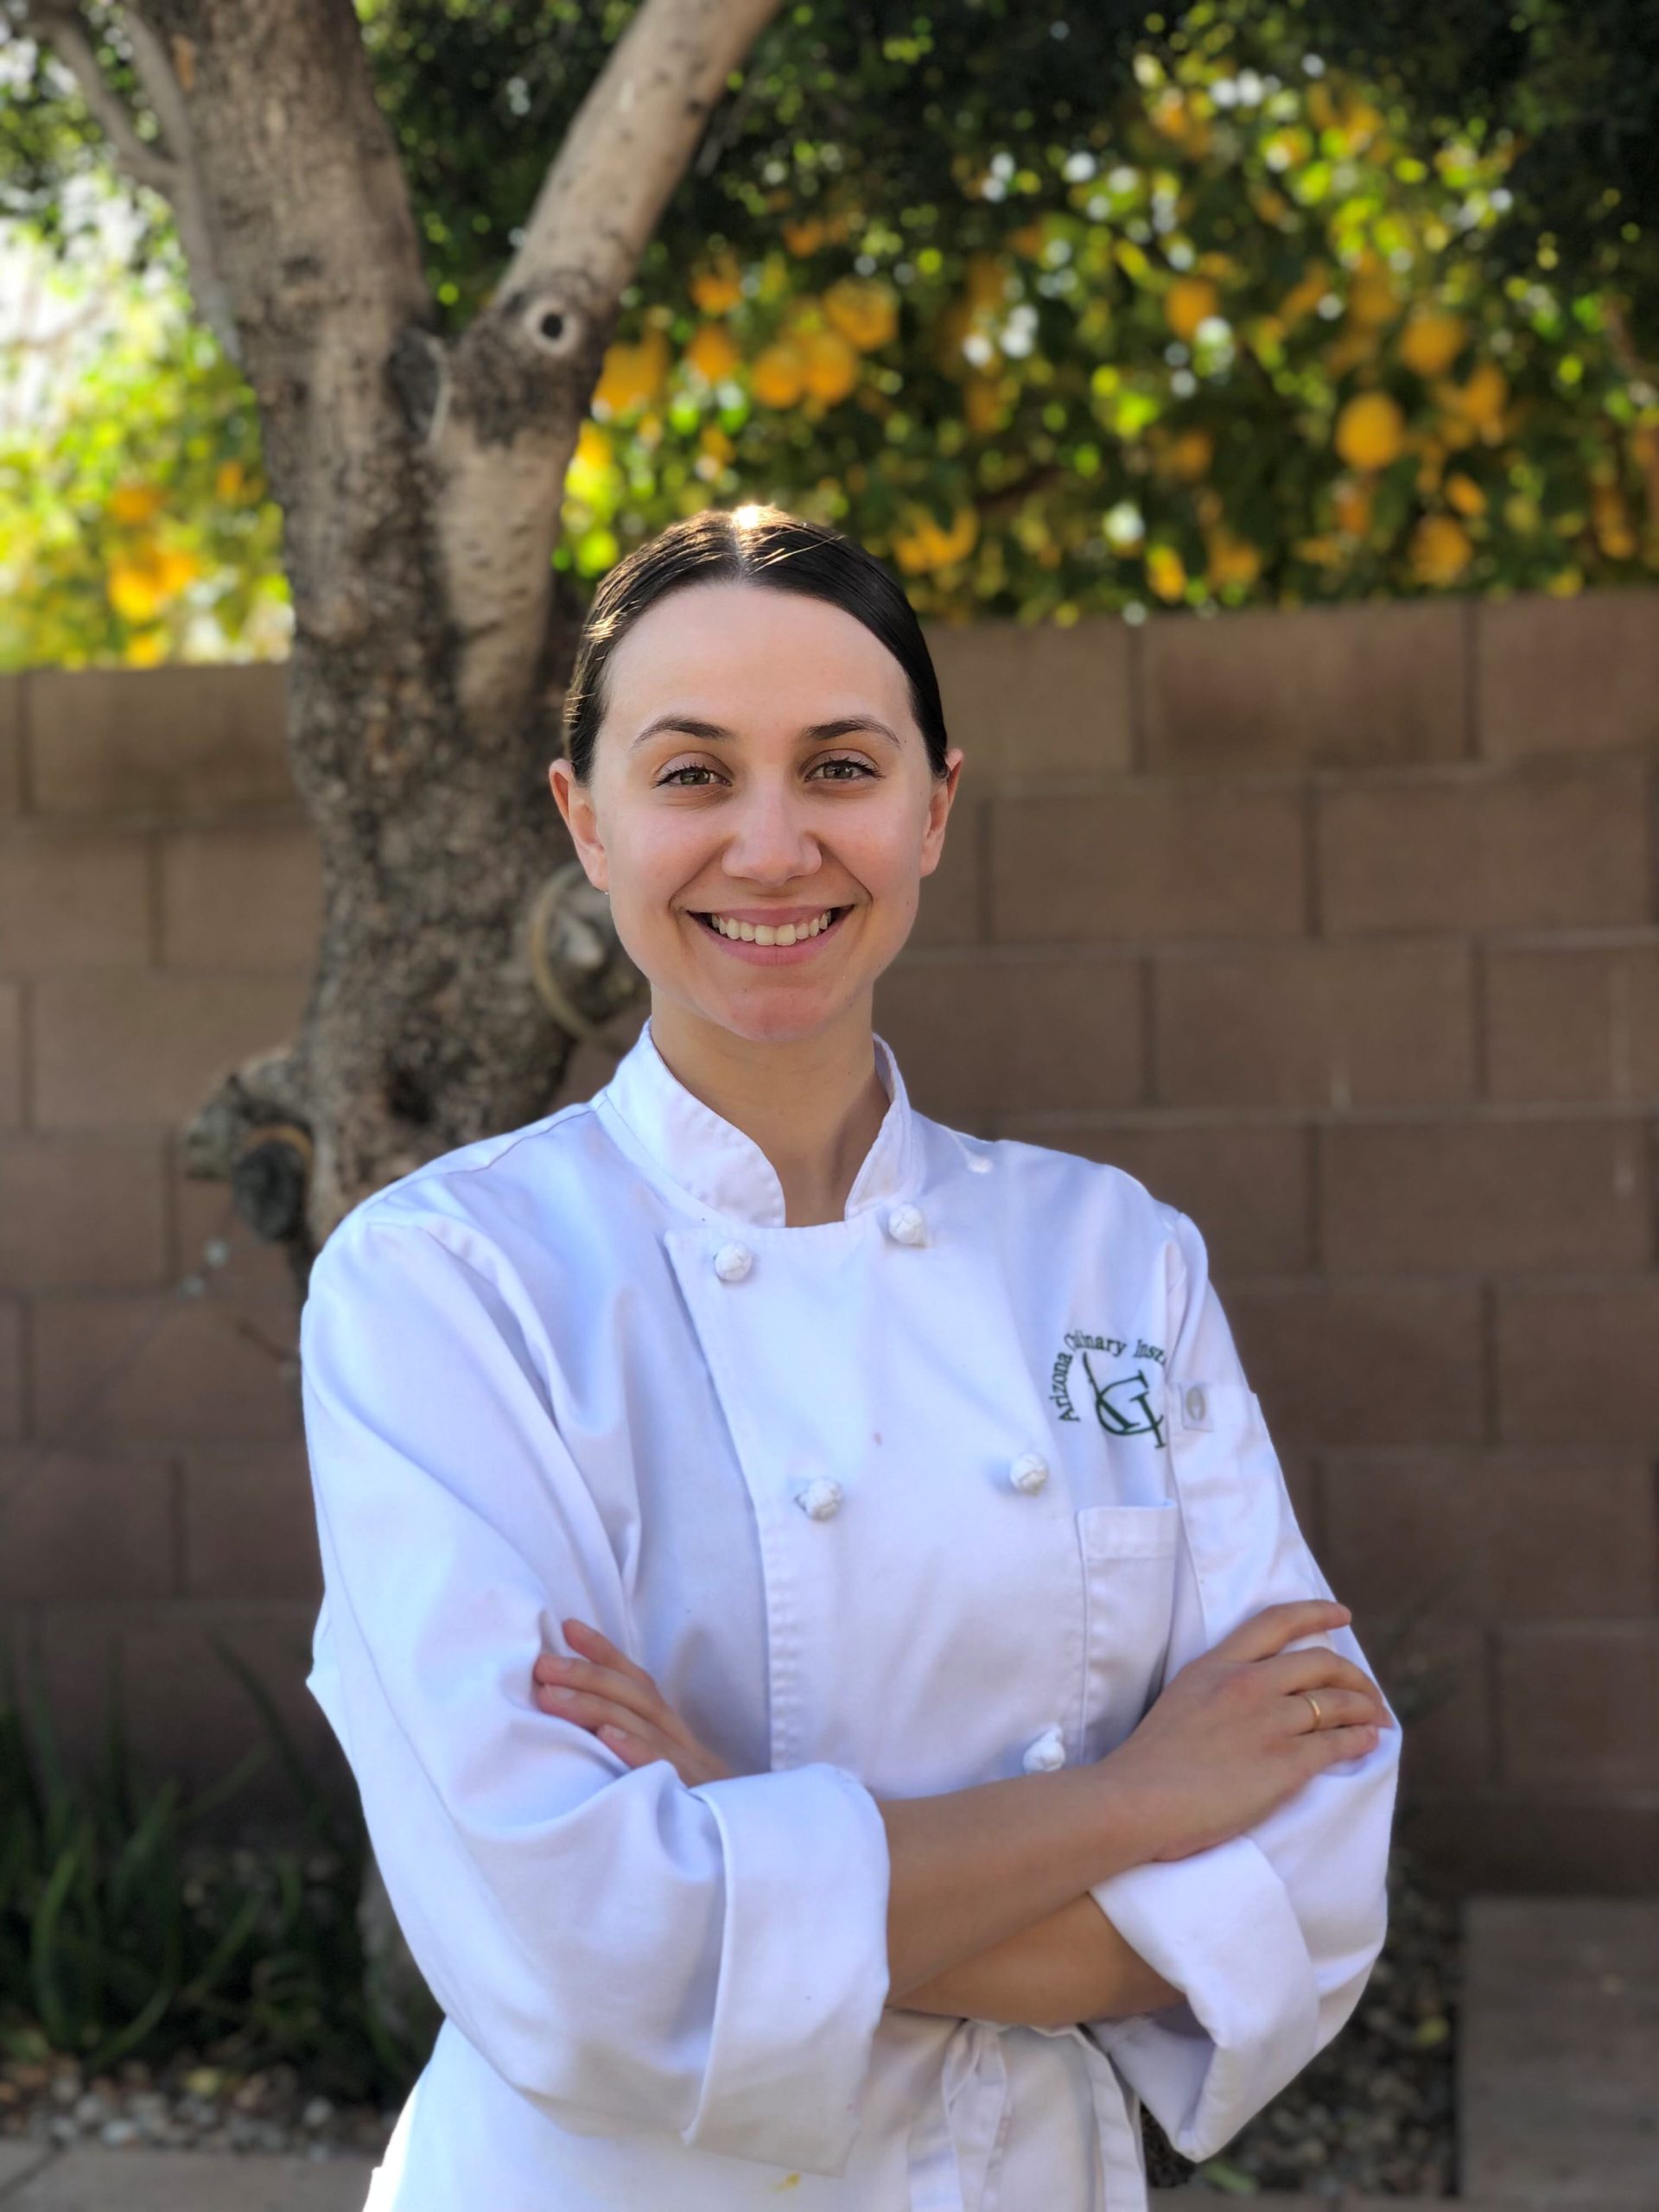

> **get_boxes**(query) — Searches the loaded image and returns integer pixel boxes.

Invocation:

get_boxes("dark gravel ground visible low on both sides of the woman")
[0,1847,1460,2196]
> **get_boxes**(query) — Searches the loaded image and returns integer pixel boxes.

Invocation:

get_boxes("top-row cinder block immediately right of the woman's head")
[925,615,1130,787]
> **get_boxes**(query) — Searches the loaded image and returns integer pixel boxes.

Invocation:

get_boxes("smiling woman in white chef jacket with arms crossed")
[301,509,1400,2212]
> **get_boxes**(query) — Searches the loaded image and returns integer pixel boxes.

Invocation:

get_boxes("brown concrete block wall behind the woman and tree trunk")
[0,591,1659,1889]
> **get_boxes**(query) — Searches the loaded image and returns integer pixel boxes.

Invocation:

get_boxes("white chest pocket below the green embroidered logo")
[1077,1500,1181,1765]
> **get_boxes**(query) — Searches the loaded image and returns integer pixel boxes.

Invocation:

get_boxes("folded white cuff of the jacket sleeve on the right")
[1089,1836,1319,2159]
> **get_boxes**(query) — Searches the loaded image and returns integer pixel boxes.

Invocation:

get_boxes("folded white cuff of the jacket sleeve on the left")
[681,1761,892,2177]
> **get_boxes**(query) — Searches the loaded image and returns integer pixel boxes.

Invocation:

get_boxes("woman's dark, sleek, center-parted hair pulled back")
[564,505,949,783]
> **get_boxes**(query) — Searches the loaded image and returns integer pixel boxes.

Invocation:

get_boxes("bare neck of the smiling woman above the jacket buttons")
[651,995,889,1228]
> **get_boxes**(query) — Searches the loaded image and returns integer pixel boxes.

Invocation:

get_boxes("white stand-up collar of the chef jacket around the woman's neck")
[593,1018,918,1230]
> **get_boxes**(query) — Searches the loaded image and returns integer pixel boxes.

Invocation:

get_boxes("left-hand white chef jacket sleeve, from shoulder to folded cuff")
[301,1205,889,2177]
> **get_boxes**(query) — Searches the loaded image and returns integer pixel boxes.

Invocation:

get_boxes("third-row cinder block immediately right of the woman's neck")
[876,951,1146,1130]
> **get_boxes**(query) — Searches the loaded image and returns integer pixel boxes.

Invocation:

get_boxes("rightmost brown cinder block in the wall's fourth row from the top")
[1319,1117,1652,1274]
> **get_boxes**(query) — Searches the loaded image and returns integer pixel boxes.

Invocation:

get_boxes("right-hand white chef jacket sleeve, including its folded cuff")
[1089,1214,1400,2159]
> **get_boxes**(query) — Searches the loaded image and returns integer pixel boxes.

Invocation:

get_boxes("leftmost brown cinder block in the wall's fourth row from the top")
[0,1137,166,1294]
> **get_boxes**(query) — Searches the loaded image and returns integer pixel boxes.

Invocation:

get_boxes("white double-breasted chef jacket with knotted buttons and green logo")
[301,1022,1400,2212]
